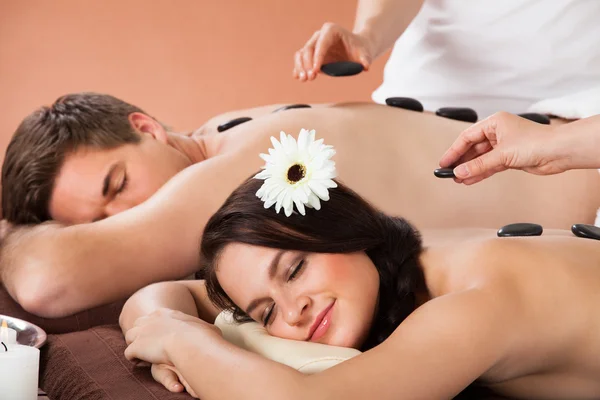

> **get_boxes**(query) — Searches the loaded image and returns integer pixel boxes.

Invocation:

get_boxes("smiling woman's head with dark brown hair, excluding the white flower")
[202,179,424,349]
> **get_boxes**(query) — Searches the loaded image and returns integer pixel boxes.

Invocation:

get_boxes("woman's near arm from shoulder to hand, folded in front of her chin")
[125,289,519,400]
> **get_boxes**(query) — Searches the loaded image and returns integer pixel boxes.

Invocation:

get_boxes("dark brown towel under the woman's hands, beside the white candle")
[40,325,192,400]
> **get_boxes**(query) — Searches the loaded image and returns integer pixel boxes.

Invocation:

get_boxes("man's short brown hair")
[2,93,148,224]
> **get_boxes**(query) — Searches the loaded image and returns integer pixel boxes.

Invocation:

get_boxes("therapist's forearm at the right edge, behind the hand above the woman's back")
[553,115,600,169]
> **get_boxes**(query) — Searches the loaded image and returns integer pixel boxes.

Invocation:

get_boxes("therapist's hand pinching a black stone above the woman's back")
[440,112,569,185]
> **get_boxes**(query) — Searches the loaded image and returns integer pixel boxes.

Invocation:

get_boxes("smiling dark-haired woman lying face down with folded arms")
[121,137,600,400]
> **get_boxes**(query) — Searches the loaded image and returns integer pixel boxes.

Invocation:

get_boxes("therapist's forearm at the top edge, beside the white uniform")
[353,0,423,58]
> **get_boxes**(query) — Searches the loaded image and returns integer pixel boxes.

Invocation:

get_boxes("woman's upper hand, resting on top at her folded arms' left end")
[125,308,221,365]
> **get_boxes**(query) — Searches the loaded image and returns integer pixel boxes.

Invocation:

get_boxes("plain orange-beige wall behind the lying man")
[0,0,385,164]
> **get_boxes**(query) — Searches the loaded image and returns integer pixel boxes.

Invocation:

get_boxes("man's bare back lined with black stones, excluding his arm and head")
[201,104,600,228]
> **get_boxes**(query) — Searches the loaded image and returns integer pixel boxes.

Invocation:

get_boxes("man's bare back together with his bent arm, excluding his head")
[3,104,600,316]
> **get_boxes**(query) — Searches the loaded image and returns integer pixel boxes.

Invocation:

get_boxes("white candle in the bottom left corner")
[0,344,40,400]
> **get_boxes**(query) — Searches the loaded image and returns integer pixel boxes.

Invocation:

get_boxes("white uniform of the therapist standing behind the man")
[373,0,600,119]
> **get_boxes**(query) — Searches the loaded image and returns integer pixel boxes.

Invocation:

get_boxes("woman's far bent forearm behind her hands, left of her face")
[119,280,220,334]
